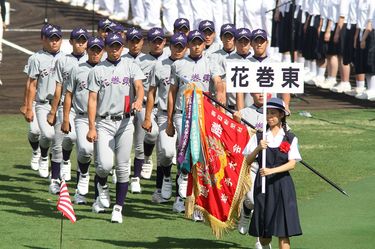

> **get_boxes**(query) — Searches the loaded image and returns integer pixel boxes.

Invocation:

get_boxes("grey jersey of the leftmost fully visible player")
[28,50,64,102]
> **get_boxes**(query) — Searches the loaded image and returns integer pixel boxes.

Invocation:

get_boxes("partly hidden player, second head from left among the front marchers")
[47,28,89,181]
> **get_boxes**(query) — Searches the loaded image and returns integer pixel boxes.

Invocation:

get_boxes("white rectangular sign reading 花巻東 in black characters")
[226,61,304,93]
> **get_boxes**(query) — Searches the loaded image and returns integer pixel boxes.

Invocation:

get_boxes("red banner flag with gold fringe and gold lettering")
[187,97,250,237]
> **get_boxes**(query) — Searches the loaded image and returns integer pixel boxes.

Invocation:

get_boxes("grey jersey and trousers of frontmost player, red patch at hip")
[88,58,145,183]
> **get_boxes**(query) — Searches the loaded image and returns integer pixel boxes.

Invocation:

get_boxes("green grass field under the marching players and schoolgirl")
[0,110,375,249]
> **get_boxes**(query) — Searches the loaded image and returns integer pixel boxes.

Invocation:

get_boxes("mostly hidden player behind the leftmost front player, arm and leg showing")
[20,24,52,170]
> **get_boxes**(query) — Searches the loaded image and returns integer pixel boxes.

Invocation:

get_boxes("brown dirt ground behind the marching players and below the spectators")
[0,0,375,114]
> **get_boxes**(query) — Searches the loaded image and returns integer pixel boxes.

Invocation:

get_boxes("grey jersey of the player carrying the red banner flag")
[171,56,224,111]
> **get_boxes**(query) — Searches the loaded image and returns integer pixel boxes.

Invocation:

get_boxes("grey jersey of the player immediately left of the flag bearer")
[150,58,175,111]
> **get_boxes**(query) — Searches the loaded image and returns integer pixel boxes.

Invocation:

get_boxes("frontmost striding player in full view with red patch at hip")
[87,33,145,223]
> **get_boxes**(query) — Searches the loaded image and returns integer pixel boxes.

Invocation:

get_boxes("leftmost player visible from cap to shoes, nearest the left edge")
[25,26,63,194]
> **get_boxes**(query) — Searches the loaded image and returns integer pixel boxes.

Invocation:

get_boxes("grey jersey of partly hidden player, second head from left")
[56,53,88,103]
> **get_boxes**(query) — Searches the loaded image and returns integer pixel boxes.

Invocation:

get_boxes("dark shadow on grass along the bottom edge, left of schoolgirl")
[87,237,252,249]
